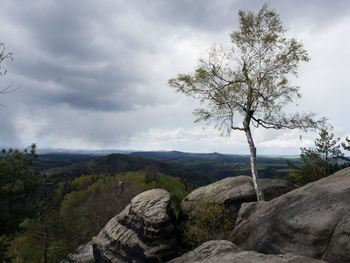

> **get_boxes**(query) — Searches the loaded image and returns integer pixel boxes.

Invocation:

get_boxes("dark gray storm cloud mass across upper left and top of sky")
[3,0,348,111]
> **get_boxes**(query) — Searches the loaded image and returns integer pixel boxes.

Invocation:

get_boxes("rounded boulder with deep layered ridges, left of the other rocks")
[93,189,177,263]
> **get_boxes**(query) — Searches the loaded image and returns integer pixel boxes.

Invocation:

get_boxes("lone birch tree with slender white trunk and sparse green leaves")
[169,5,321,201]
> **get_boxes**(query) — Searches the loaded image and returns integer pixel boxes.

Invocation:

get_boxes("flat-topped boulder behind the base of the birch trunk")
[181,176,295,218]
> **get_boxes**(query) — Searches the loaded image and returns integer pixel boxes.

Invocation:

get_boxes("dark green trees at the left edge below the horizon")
[0,144,44,262]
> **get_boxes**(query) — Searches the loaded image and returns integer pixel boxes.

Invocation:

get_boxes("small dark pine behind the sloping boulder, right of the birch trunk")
[288,126,344,185]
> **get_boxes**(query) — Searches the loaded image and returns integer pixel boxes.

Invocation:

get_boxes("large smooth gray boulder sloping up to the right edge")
[232,168,350,263]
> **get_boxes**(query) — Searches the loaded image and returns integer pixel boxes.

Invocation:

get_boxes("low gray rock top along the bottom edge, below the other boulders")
[168,240,325,263]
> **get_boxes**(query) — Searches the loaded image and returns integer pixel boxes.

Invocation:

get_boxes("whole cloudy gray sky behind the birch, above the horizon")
[0,0,350,154]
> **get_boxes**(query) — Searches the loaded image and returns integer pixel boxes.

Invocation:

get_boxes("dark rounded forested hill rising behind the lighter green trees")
[44,154,212,185]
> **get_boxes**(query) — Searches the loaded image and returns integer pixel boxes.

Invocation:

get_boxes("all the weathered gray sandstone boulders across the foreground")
[72,168,350,263]
